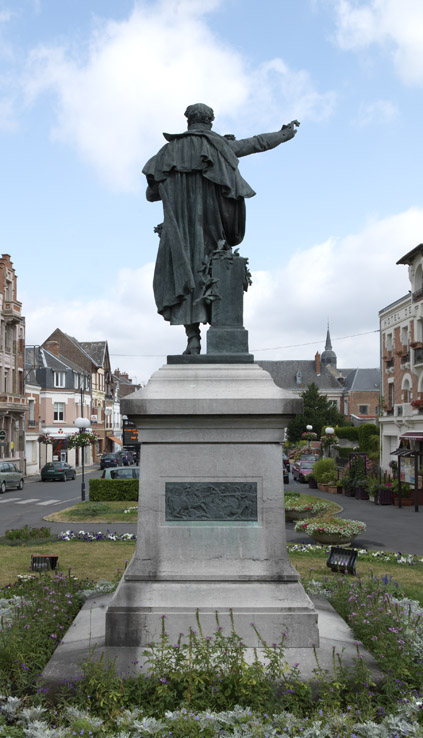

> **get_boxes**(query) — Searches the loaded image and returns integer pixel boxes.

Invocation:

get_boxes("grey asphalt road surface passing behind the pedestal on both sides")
[0,468,423,556]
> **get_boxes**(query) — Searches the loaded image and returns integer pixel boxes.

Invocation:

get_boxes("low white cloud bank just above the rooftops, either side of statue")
[21,208,423,381]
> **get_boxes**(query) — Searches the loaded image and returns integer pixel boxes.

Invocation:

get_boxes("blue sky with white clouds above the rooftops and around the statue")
[0,0,423,383]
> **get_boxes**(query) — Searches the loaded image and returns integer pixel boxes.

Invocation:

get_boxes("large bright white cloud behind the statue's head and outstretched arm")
[25,0,334,190]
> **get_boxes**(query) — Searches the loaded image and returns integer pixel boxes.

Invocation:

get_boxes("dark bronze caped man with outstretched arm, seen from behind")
[143,103,299,354]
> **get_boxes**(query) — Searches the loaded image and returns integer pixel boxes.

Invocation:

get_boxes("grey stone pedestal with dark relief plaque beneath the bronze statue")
[106,364,318,648]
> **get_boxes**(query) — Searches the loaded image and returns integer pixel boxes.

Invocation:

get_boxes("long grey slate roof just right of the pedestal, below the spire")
[255,359,342,392]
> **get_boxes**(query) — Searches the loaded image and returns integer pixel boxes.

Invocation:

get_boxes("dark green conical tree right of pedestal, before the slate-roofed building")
[287,382,345,443]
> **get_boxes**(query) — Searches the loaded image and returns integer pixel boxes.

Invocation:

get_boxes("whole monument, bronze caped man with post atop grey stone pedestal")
[106,104,319,648]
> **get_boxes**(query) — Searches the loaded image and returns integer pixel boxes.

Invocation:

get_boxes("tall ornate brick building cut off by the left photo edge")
[0,254,27,473]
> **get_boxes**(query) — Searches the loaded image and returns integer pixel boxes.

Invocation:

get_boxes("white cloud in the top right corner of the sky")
[335,0,423,85]
